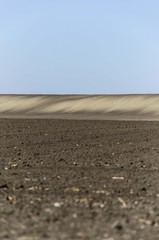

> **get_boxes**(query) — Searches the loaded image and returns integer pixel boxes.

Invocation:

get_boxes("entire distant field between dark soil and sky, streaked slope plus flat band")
[0,95,159,120]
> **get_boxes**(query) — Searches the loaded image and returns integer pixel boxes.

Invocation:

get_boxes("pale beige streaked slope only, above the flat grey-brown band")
[0,95,159,115]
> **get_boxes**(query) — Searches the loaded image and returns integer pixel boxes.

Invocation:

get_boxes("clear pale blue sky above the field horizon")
[0,0,159,94]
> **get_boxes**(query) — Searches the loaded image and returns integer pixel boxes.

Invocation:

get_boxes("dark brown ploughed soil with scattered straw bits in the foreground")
[0,119,159,240]
